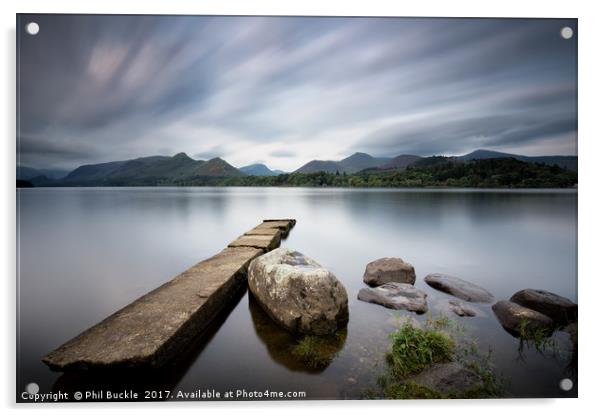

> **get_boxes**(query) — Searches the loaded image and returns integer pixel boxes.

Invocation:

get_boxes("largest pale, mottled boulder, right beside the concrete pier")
[249,248,349,335]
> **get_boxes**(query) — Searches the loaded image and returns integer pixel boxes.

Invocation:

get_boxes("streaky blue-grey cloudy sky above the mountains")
[17,15,577,171]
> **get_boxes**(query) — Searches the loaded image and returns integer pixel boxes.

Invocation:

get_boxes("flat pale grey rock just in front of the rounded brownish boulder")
[357,282,428,314]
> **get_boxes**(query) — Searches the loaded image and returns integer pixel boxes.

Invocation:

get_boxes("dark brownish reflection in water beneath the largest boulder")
[249,293,347,374]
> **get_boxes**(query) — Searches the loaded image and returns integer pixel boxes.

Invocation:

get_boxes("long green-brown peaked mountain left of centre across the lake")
[62,152,245,185]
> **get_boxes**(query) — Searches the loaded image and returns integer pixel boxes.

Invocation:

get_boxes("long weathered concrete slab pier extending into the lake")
[42,219,295,371]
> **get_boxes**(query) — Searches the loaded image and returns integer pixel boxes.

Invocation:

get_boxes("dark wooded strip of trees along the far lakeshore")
[17,156,578,188]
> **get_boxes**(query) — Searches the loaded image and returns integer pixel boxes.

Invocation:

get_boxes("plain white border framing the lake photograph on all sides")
[0,0,602,417]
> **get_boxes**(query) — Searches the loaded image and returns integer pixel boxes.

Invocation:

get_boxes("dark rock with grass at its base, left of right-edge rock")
[491,300,554,337]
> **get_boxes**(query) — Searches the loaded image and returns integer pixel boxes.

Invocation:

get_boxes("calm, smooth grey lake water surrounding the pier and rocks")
[17,188,577,399]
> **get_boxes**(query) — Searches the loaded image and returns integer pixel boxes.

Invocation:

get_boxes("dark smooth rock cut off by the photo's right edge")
[510,289,577,323]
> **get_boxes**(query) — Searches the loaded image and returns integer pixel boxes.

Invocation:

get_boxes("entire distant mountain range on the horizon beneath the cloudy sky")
[17,149,577,186]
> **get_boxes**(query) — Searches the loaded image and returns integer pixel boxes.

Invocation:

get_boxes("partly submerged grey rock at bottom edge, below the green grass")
[412,362,482,394]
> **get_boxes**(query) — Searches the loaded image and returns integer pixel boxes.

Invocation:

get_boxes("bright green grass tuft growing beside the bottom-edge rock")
[386,323,455,377]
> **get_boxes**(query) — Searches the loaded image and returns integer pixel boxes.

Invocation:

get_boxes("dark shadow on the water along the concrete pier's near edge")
[53,285,247,401]
